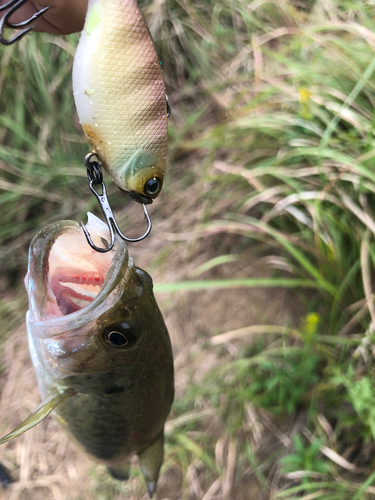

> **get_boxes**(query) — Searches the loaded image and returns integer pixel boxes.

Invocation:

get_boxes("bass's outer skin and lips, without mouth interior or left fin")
[26,221,174,496]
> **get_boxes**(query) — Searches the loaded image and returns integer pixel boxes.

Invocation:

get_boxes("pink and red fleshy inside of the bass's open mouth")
[43,214,113,319]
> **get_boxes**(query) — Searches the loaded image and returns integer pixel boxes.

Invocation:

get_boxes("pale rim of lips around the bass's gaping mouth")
[27,221,130,339]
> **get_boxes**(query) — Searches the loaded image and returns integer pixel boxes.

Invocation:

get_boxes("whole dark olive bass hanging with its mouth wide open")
[0,214,174,497]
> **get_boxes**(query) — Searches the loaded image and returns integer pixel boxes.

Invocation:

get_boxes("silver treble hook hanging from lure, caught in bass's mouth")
[81,153,152,253]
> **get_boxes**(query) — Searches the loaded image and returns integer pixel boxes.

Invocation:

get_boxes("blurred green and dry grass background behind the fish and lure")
[0,0,375,500]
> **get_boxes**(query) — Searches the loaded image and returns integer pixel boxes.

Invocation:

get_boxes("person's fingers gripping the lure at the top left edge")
[0,0,88,35]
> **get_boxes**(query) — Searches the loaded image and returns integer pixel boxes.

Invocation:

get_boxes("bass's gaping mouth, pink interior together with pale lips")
[25,213,129,330]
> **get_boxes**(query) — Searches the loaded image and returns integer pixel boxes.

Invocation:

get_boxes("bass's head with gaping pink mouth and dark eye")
[25,214,170,394]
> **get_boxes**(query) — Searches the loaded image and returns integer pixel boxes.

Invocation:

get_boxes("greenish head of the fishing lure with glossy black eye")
[119,150,165,204]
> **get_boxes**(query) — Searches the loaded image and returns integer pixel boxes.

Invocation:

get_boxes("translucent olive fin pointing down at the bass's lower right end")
[138,432,164,498]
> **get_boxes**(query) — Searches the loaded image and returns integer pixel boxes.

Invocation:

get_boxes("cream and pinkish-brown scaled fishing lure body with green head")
[73,0,168,204]
